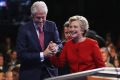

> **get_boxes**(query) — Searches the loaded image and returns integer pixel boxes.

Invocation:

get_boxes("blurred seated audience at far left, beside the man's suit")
[0,37,20,80]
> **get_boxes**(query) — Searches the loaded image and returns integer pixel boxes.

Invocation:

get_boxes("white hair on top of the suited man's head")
[31,1,48,15]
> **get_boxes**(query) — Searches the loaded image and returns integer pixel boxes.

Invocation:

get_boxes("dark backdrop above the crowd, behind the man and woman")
[0,0,120,45]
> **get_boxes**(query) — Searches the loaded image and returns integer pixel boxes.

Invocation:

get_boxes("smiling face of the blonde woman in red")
[70,20,83,39]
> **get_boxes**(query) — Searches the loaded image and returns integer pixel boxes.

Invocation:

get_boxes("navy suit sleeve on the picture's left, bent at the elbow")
[16,26,40,64]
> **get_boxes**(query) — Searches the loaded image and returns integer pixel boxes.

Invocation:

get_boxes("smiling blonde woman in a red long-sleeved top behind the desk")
[51,15,105,73]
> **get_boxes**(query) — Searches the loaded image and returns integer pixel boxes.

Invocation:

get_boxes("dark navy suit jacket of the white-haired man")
[16,20,61,80]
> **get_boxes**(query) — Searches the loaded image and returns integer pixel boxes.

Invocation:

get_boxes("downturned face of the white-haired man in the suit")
[33,13,47,27]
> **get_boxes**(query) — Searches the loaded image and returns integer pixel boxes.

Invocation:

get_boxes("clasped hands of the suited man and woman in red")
[43,41,58,56]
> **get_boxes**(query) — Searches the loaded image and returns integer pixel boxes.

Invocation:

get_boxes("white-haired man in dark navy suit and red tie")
[16,1,61,80]
